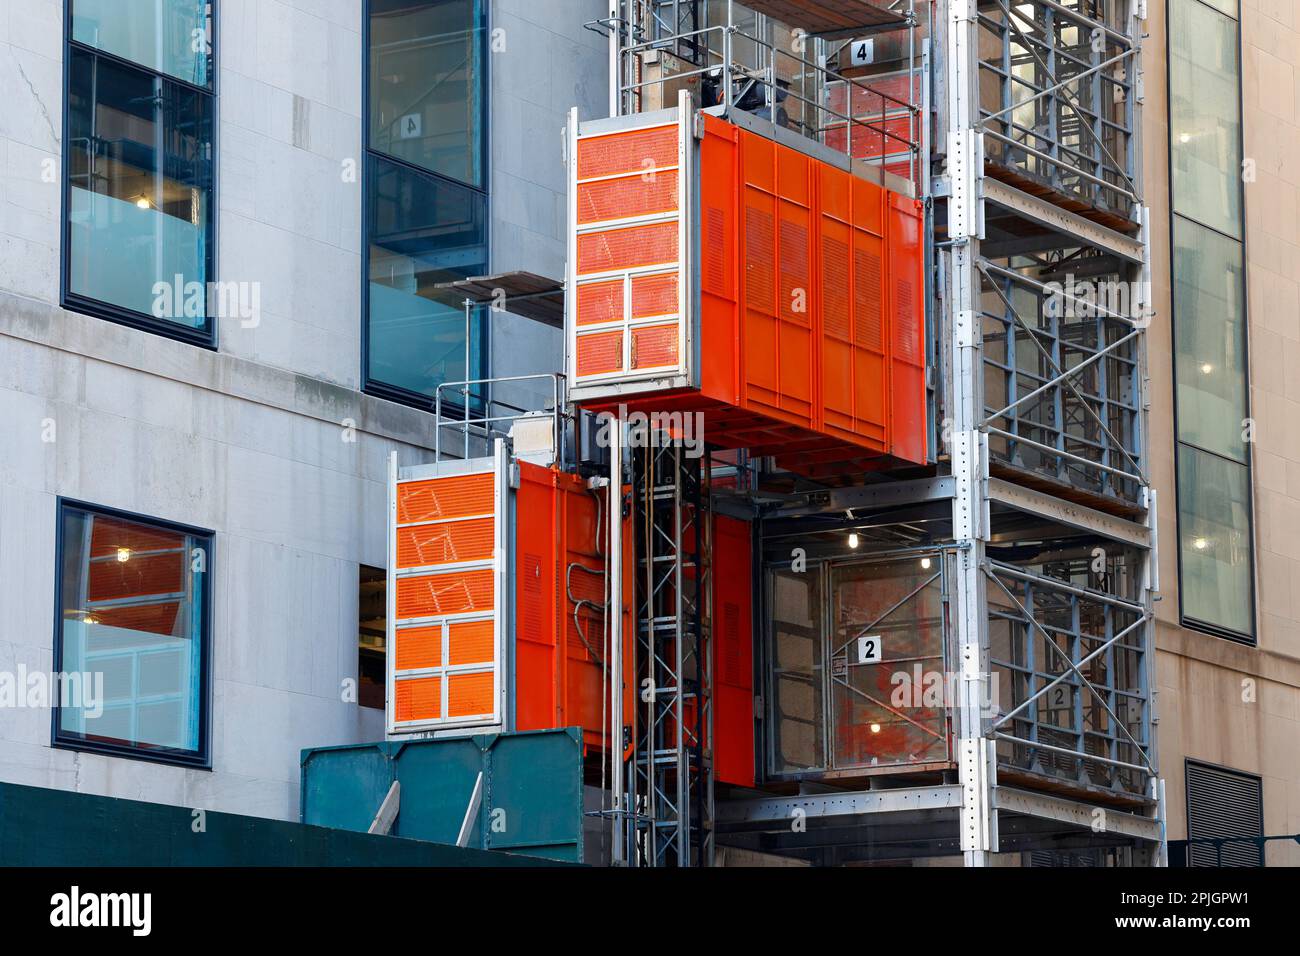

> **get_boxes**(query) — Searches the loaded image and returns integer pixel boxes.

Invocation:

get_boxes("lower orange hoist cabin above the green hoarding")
[386,441,633,748]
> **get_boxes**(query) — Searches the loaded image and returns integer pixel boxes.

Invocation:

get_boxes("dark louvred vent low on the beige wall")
[1187,761,1264,866]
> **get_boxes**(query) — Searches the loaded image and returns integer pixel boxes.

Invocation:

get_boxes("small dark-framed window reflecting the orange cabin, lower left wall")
[55,501,212,766]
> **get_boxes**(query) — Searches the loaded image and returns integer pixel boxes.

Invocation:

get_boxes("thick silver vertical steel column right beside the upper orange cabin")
[944,0,997,866]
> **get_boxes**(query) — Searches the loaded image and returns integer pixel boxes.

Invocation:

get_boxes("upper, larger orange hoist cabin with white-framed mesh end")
[566,95,927,475]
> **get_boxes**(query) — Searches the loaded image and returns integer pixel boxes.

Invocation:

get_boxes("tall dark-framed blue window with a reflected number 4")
[363,0,488,408]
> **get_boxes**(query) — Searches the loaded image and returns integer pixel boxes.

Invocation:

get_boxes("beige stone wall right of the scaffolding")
[1143,0,1300,865]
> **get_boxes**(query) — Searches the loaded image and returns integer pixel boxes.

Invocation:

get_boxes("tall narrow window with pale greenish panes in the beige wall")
[1169,0,1255,644]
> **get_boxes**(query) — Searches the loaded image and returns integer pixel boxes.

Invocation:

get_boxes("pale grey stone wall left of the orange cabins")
[0,0,605,818]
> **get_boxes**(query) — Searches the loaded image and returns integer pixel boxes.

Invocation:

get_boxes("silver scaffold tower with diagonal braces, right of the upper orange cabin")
[936,0,1162,866]
